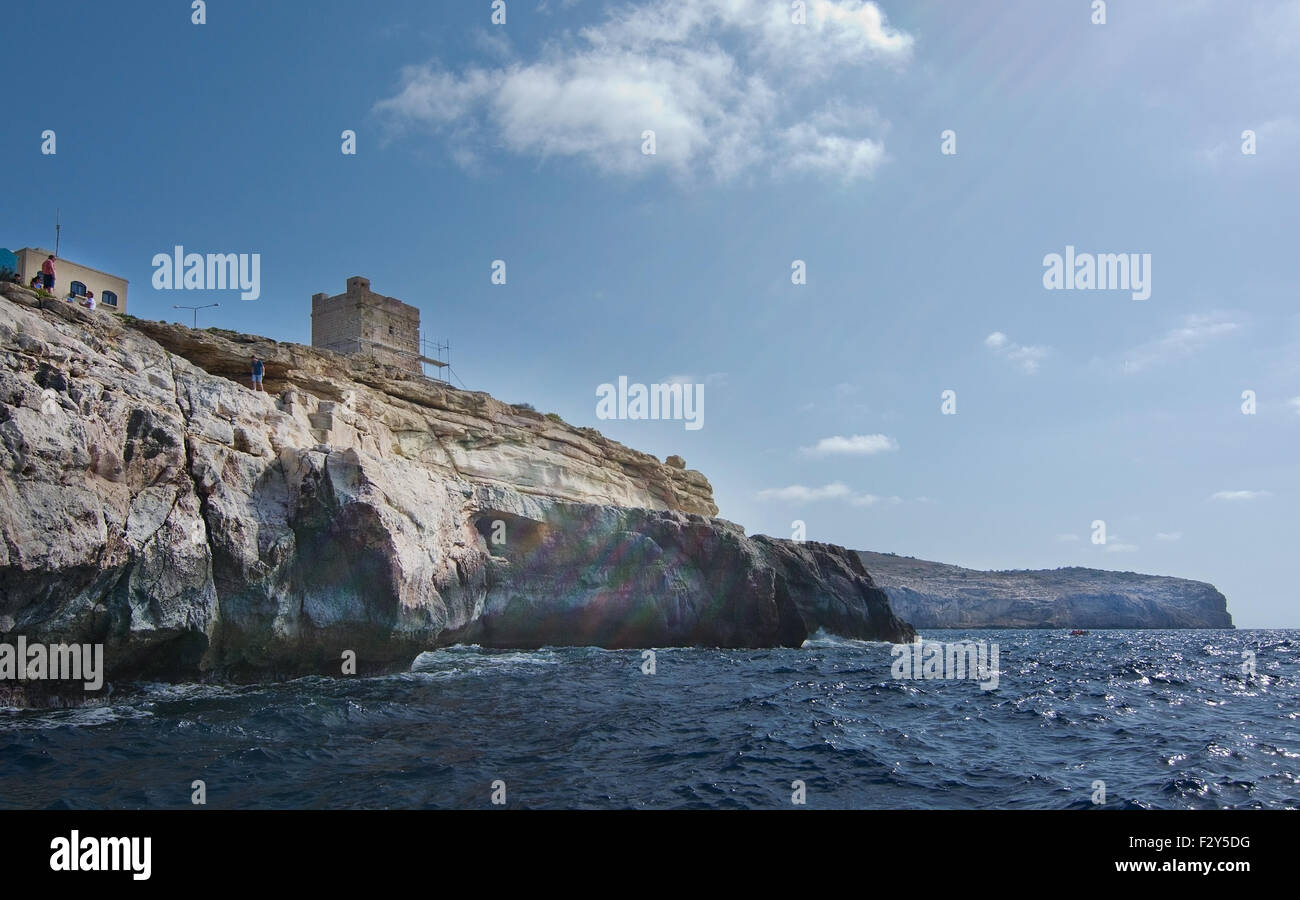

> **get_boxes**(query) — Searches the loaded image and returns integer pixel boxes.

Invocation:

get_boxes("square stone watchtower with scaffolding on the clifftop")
[312,276,441,375]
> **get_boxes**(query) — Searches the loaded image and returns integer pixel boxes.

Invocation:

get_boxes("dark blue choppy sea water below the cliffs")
[0,631,1300,808]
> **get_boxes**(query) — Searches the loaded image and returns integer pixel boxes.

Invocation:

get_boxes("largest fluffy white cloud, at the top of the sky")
[374,0,913,179]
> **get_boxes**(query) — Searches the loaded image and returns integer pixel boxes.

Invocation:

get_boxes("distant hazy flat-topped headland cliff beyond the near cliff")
[858,550,1232,628]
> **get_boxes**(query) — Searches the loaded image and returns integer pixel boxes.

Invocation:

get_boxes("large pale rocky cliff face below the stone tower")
[0,285,913,678]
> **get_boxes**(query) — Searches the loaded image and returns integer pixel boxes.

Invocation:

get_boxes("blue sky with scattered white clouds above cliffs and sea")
[0,0,1300,627]
